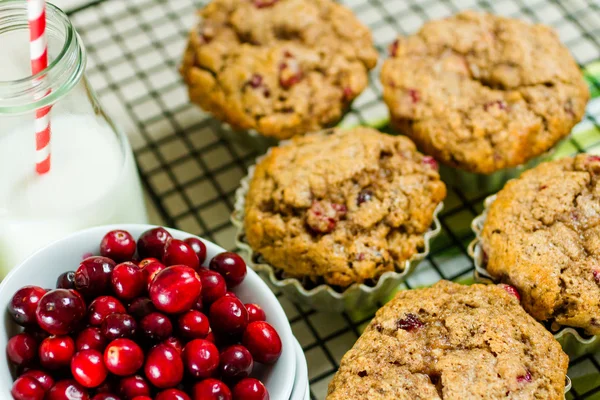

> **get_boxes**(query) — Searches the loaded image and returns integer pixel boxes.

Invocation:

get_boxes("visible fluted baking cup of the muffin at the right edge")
[468,194,600,359]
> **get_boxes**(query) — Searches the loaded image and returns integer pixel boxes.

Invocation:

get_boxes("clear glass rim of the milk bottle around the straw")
[0,0,86,115]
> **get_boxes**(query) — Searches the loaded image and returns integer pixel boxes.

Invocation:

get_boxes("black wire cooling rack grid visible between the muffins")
[65,0,600,400]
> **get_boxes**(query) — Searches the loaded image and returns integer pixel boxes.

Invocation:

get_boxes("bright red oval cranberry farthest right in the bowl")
[242,321,281,364]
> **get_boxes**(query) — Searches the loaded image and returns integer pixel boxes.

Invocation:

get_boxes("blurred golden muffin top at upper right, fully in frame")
[381,11,589,174]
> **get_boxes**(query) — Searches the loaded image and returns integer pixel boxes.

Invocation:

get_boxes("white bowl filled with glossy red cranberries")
[0,225,296,400]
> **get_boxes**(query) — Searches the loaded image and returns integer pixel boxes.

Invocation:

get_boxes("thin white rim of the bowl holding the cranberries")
[0,224,297,398]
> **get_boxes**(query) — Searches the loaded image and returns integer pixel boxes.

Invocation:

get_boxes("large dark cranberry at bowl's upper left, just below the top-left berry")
[75,257,116,298]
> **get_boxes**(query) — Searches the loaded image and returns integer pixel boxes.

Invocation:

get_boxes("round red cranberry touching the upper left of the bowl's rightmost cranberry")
[210,296,248,335]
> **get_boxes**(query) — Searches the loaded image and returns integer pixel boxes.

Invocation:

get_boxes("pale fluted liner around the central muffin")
[231,141,443,312]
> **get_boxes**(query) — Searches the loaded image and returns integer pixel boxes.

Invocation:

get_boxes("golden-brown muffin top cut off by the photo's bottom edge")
[327,281,568,400]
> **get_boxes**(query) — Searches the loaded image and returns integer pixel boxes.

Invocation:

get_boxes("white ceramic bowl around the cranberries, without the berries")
[0,224,297,400]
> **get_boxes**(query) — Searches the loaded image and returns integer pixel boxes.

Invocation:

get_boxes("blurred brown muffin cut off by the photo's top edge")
[181,0,377,139]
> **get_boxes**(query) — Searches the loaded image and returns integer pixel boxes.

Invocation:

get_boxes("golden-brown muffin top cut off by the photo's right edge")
[481,154,600,335]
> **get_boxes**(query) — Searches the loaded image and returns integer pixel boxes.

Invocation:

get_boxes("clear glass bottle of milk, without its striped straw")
[0,0,147,278]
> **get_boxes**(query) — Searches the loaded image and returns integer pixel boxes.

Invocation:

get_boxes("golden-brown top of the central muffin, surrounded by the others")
[244,128,446,288]
